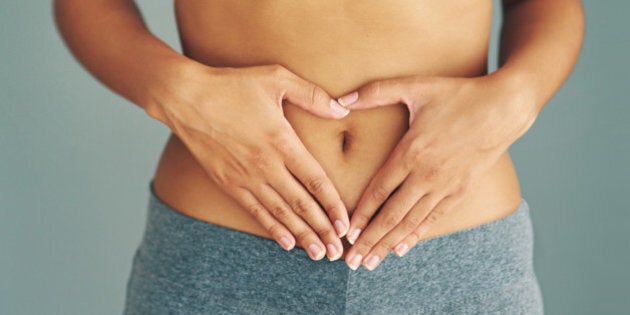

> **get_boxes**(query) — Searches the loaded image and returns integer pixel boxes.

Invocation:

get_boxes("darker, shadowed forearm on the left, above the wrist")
[54,0,195,113]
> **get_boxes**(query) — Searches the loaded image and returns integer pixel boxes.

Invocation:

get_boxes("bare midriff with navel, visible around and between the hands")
[154,0,521,247]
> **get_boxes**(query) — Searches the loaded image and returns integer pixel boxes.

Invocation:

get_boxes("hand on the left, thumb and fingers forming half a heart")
[145,62,349,260]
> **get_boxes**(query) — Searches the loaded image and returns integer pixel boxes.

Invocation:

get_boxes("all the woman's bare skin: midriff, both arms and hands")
[56,0,583,269]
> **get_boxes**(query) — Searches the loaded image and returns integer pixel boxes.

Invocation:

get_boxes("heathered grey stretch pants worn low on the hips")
[125,184,543,314]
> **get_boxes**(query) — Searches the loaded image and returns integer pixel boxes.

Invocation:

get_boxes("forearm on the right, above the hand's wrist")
[492,0,584,120]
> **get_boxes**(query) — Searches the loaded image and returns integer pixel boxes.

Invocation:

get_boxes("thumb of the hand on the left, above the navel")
[282,70,350,119]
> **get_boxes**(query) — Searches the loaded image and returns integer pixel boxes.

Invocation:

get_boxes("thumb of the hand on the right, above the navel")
[337,79,406,109]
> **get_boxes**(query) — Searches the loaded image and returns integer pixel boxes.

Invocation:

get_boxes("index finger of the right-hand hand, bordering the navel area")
[347,150,409,244]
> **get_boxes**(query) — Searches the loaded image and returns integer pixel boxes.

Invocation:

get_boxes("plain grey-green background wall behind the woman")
[0,0,630,314]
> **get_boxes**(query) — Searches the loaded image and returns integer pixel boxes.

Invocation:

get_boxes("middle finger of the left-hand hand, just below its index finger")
[270,170,343,261]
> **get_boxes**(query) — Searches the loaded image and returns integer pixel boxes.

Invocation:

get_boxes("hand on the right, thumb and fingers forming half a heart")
[339,75,535,270]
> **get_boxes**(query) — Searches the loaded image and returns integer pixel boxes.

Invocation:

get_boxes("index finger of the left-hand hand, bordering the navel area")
[282,138,350,237]
